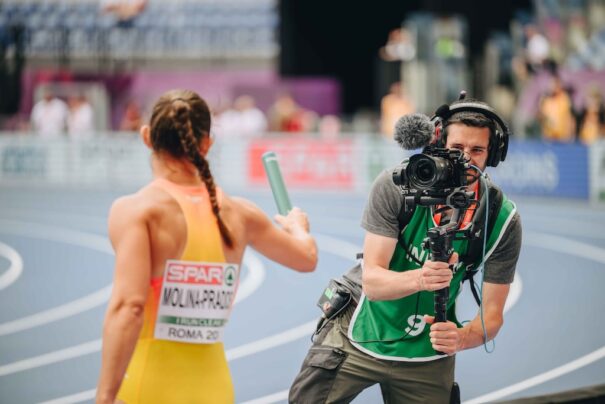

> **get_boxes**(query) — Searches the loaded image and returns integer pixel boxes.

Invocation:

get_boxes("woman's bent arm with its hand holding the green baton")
[233,198,317,272]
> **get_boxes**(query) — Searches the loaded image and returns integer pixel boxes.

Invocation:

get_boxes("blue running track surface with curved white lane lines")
[0,187,605,403]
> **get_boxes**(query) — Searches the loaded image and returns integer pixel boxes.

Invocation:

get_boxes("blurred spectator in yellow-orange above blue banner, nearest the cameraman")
[539,76,575,142]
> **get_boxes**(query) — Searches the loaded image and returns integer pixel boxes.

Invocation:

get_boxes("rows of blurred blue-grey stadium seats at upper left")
[0,0,278,59]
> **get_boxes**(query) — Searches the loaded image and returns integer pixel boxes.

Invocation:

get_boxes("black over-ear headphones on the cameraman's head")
[433,98,511,167]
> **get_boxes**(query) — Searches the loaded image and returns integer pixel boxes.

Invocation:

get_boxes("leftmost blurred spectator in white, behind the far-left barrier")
[31,89,68,138]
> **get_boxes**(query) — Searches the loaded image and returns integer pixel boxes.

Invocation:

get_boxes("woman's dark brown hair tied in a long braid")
[150,90,233,248]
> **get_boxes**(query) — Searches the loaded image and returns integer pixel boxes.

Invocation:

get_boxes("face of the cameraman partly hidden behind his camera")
[445,123,489,171]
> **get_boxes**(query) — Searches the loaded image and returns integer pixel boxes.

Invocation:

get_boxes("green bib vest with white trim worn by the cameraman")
[348,195,516,361]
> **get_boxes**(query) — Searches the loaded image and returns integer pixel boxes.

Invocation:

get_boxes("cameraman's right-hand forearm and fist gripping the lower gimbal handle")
[425,282,510,355]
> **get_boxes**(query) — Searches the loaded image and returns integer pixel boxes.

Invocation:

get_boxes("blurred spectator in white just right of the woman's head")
[216,95,267,137]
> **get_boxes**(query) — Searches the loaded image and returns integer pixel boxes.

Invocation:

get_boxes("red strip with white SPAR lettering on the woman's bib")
[166,262,224,286]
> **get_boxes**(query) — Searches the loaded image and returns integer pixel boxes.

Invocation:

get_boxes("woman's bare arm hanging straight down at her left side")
[97,197,151,404]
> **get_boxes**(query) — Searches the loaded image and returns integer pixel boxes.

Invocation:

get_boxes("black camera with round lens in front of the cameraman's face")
[392,145,470,208]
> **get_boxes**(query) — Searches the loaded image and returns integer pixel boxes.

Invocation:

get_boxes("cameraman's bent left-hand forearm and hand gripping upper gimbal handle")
[362,231,458,300]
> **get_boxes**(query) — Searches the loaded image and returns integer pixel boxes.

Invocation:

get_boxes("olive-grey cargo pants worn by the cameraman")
[288,304,455,404]
